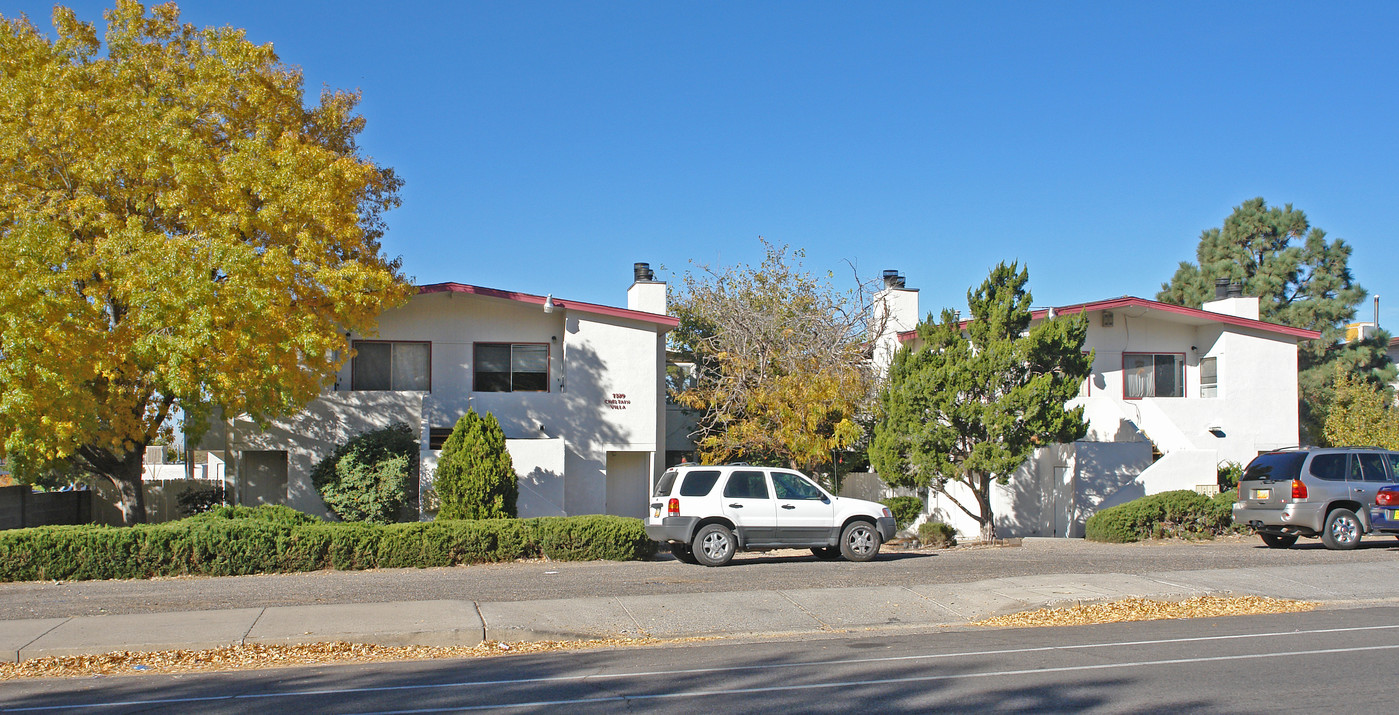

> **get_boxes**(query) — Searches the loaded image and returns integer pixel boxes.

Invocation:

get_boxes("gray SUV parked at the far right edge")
[1234,446,1399,548]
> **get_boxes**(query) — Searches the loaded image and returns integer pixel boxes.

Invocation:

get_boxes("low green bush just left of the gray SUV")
[1084,490,1234,543]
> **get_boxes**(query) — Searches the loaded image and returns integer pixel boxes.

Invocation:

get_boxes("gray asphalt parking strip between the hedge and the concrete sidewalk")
[0,537,1399,620]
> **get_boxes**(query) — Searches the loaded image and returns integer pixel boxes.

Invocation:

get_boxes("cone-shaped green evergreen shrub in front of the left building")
[432,410,519,519]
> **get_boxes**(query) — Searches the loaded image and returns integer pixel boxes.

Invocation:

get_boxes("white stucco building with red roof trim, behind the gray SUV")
[874,278,1319,537]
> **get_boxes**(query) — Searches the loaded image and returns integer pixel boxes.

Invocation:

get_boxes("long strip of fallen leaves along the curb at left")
[0,638,709,680]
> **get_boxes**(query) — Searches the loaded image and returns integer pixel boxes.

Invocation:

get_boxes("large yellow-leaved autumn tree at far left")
[0,0,411,523]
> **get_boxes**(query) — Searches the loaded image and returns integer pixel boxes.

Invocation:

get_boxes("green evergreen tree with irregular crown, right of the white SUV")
[870,263,1093,540]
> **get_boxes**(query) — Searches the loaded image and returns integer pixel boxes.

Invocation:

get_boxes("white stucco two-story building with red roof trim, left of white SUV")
[212,263,677,518]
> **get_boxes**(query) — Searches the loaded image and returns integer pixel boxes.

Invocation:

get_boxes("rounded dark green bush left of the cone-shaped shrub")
[311,423,418,523]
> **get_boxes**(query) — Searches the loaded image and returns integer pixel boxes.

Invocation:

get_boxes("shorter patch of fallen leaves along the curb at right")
[971,596,1316,628]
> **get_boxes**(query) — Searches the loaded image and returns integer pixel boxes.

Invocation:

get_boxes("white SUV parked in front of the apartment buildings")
[646,465,894,567]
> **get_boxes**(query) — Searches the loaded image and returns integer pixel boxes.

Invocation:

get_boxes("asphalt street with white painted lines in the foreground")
[0,607,1399,715]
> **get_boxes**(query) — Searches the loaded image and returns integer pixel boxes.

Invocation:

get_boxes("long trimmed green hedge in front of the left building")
[0,507,656,581]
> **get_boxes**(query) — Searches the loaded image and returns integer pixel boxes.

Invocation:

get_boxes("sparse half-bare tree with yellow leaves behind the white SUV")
[672,241,873,473]
